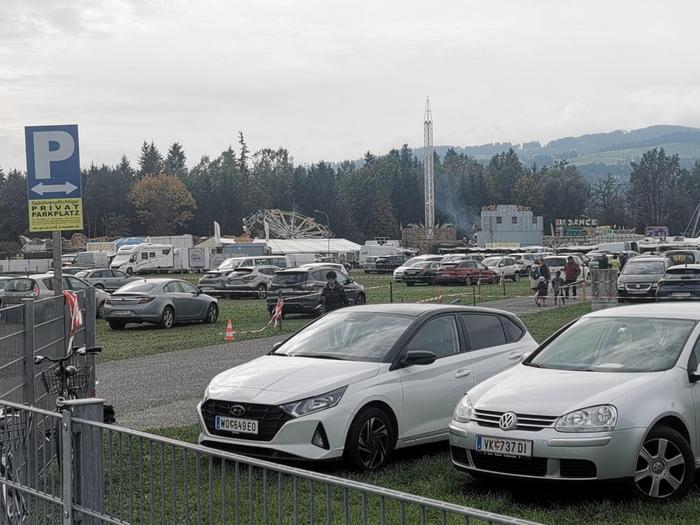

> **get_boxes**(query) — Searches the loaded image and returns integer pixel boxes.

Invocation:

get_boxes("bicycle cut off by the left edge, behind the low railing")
[0,409,29,525]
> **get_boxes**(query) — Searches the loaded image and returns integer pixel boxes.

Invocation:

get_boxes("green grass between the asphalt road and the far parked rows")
[97,272,529,362]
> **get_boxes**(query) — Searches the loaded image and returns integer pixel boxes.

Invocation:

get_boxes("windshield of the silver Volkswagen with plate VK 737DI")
[525,317,695,372]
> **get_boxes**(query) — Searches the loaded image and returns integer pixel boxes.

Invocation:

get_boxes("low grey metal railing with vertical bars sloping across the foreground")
[0,400,533,525]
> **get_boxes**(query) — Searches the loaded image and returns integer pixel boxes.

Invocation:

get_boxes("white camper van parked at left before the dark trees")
[110,243,189,275]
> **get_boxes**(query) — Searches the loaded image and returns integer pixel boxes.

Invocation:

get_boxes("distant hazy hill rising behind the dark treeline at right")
[415,126,700,180]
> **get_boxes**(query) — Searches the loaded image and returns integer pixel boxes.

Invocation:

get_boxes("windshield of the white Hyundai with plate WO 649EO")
[273,308,413,363]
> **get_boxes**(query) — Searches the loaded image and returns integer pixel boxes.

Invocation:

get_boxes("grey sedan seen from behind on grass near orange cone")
[104,279,219,330]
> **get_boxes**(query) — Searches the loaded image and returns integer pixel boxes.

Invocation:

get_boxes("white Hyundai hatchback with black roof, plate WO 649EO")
[198,304,537,470]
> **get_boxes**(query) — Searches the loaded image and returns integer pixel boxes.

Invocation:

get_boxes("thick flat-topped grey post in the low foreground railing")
[63,398,104,525]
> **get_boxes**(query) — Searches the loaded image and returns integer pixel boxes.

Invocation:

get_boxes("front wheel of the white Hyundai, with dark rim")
[344,406,396,472]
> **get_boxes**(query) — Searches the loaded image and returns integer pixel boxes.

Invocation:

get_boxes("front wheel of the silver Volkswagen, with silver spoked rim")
[632,426,695,501]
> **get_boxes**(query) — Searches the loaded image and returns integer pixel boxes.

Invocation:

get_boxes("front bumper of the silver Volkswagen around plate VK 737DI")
[449,421,646,481]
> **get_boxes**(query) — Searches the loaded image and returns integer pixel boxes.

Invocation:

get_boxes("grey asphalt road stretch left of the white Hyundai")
[97,334,285,430]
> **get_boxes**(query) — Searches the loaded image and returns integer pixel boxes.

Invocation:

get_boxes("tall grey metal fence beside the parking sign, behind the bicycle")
[0,290,95,410]
